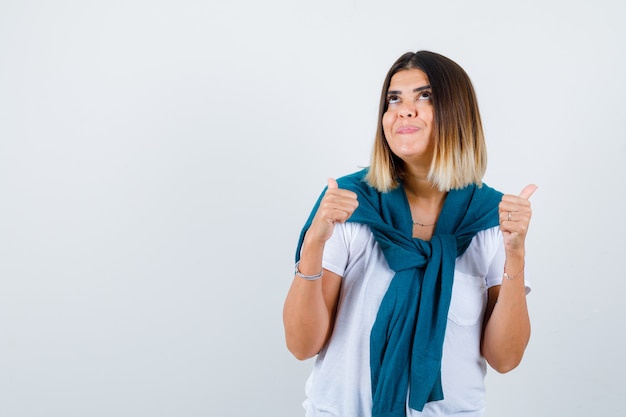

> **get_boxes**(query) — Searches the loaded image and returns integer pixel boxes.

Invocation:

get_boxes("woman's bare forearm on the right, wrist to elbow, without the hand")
[482,253,530,373]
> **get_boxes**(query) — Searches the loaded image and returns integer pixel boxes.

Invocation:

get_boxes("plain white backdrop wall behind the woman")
[0,0,626,417]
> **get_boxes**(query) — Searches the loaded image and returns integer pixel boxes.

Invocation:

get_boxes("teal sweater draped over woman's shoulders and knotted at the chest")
[296,169,502,417]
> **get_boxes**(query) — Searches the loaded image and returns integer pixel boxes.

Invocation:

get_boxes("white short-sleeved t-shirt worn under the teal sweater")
[303,223,528,417]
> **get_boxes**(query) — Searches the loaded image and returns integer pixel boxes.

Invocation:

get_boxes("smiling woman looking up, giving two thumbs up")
[284,51,536,417]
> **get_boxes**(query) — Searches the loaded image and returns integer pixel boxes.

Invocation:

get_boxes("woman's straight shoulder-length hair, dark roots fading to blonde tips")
[366,51,487,192]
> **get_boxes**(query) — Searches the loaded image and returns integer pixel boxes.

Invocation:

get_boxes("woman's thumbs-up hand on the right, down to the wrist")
[498,184,537,251]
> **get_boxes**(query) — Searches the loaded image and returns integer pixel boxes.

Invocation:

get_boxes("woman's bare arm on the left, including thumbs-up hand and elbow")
[283,179,358,360]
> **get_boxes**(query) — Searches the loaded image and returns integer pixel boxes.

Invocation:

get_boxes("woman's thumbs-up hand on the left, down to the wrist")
[306,178,359,243]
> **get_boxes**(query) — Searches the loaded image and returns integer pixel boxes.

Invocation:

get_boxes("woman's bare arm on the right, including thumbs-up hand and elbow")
[481,185,537,373]
